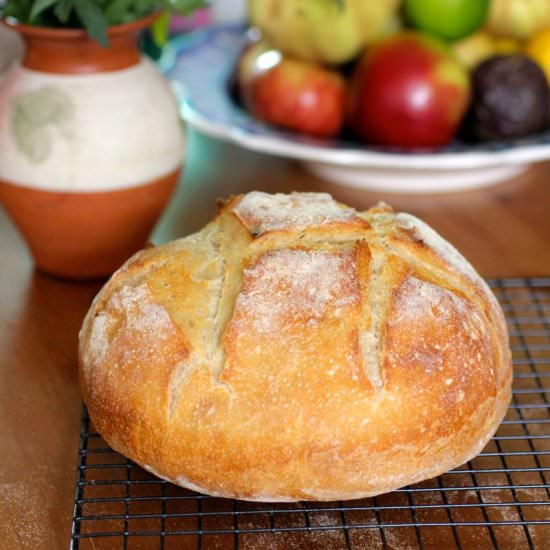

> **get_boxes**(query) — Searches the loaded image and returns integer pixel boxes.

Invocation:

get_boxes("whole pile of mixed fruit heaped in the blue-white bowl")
[236,0,550,149]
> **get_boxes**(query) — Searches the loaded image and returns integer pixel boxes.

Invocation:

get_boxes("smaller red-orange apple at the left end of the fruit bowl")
[238,43,346,137]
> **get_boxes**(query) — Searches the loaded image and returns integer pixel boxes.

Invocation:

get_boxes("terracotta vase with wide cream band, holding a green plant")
[0,17,185,278]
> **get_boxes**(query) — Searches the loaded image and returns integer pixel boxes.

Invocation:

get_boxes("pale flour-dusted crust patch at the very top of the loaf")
[233,191,356,235]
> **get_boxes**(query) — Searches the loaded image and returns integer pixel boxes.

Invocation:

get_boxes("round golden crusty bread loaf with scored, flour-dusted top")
[80,192,512,502]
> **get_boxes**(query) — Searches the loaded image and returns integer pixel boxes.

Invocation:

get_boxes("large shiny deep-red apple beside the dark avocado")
[348,31,470,148]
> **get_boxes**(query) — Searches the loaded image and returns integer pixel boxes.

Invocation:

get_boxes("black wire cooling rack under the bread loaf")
[71,278,550,550]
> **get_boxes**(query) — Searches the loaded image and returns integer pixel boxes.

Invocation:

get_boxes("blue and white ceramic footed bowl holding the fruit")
[164,26,550,193]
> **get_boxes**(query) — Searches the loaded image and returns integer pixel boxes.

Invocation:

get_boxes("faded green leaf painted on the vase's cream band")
[10,86,75,163]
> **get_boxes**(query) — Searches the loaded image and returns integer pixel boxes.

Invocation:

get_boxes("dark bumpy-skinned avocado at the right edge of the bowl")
[462,54,550,141]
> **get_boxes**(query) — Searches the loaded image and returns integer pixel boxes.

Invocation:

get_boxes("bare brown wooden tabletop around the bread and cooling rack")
[0,132,550,550]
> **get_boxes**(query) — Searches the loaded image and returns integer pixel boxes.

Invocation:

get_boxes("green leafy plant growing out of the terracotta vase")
[0,0,206,46]
